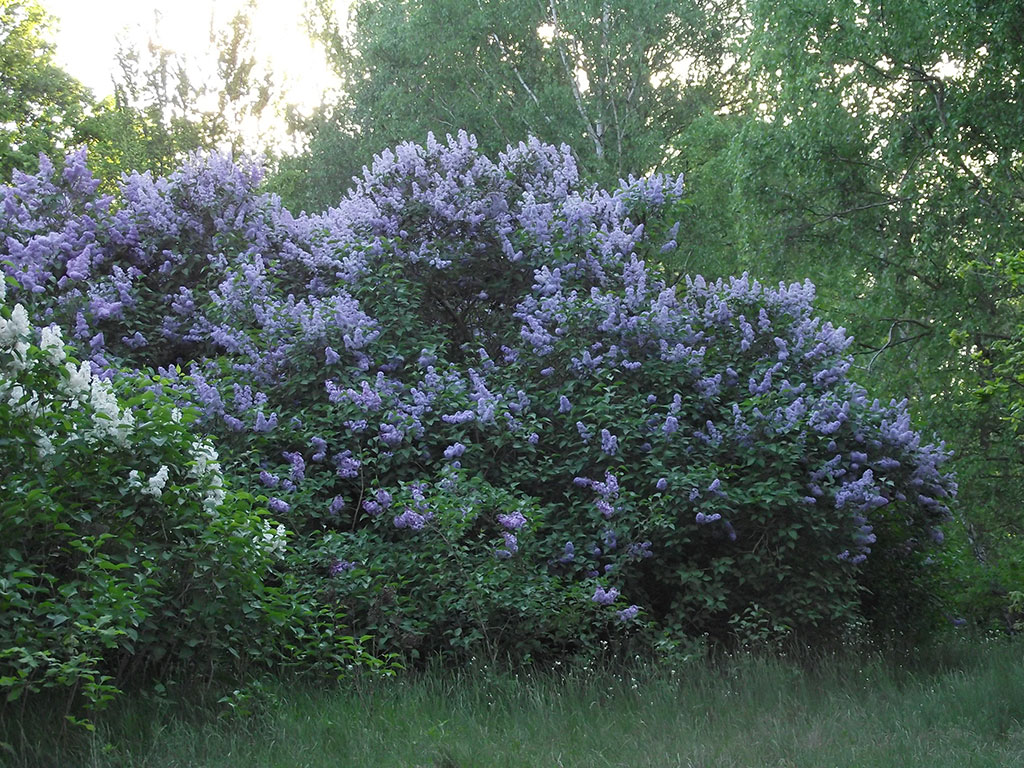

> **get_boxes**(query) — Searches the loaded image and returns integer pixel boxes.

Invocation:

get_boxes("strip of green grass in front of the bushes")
[0,644,1024,768]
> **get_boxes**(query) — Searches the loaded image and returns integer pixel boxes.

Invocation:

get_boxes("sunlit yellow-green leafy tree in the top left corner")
[0,0,91,179]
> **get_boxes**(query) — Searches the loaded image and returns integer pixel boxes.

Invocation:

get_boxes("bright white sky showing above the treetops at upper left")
[40,0,347,118]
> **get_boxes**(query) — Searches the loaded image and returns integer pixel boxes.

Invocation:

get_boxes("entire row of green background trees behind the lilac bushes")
[8,0,1024,622]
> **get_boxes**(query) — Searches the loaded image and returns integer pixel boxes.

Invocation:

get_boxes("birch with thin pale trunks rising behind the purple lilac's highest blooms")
[276,0,737,210]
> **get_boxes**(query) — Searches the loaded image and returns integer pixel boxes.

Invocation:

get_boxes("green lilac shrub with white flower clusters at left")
[0,281,372,706]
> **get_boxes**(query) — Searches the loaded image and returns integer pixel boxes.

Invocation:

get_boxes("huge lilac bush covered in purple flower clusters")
[0,134,955,663]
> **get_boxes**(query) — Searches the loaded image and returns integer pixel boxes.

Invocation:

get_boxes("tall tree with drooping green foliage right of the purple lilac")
[716,0,1024,626]
